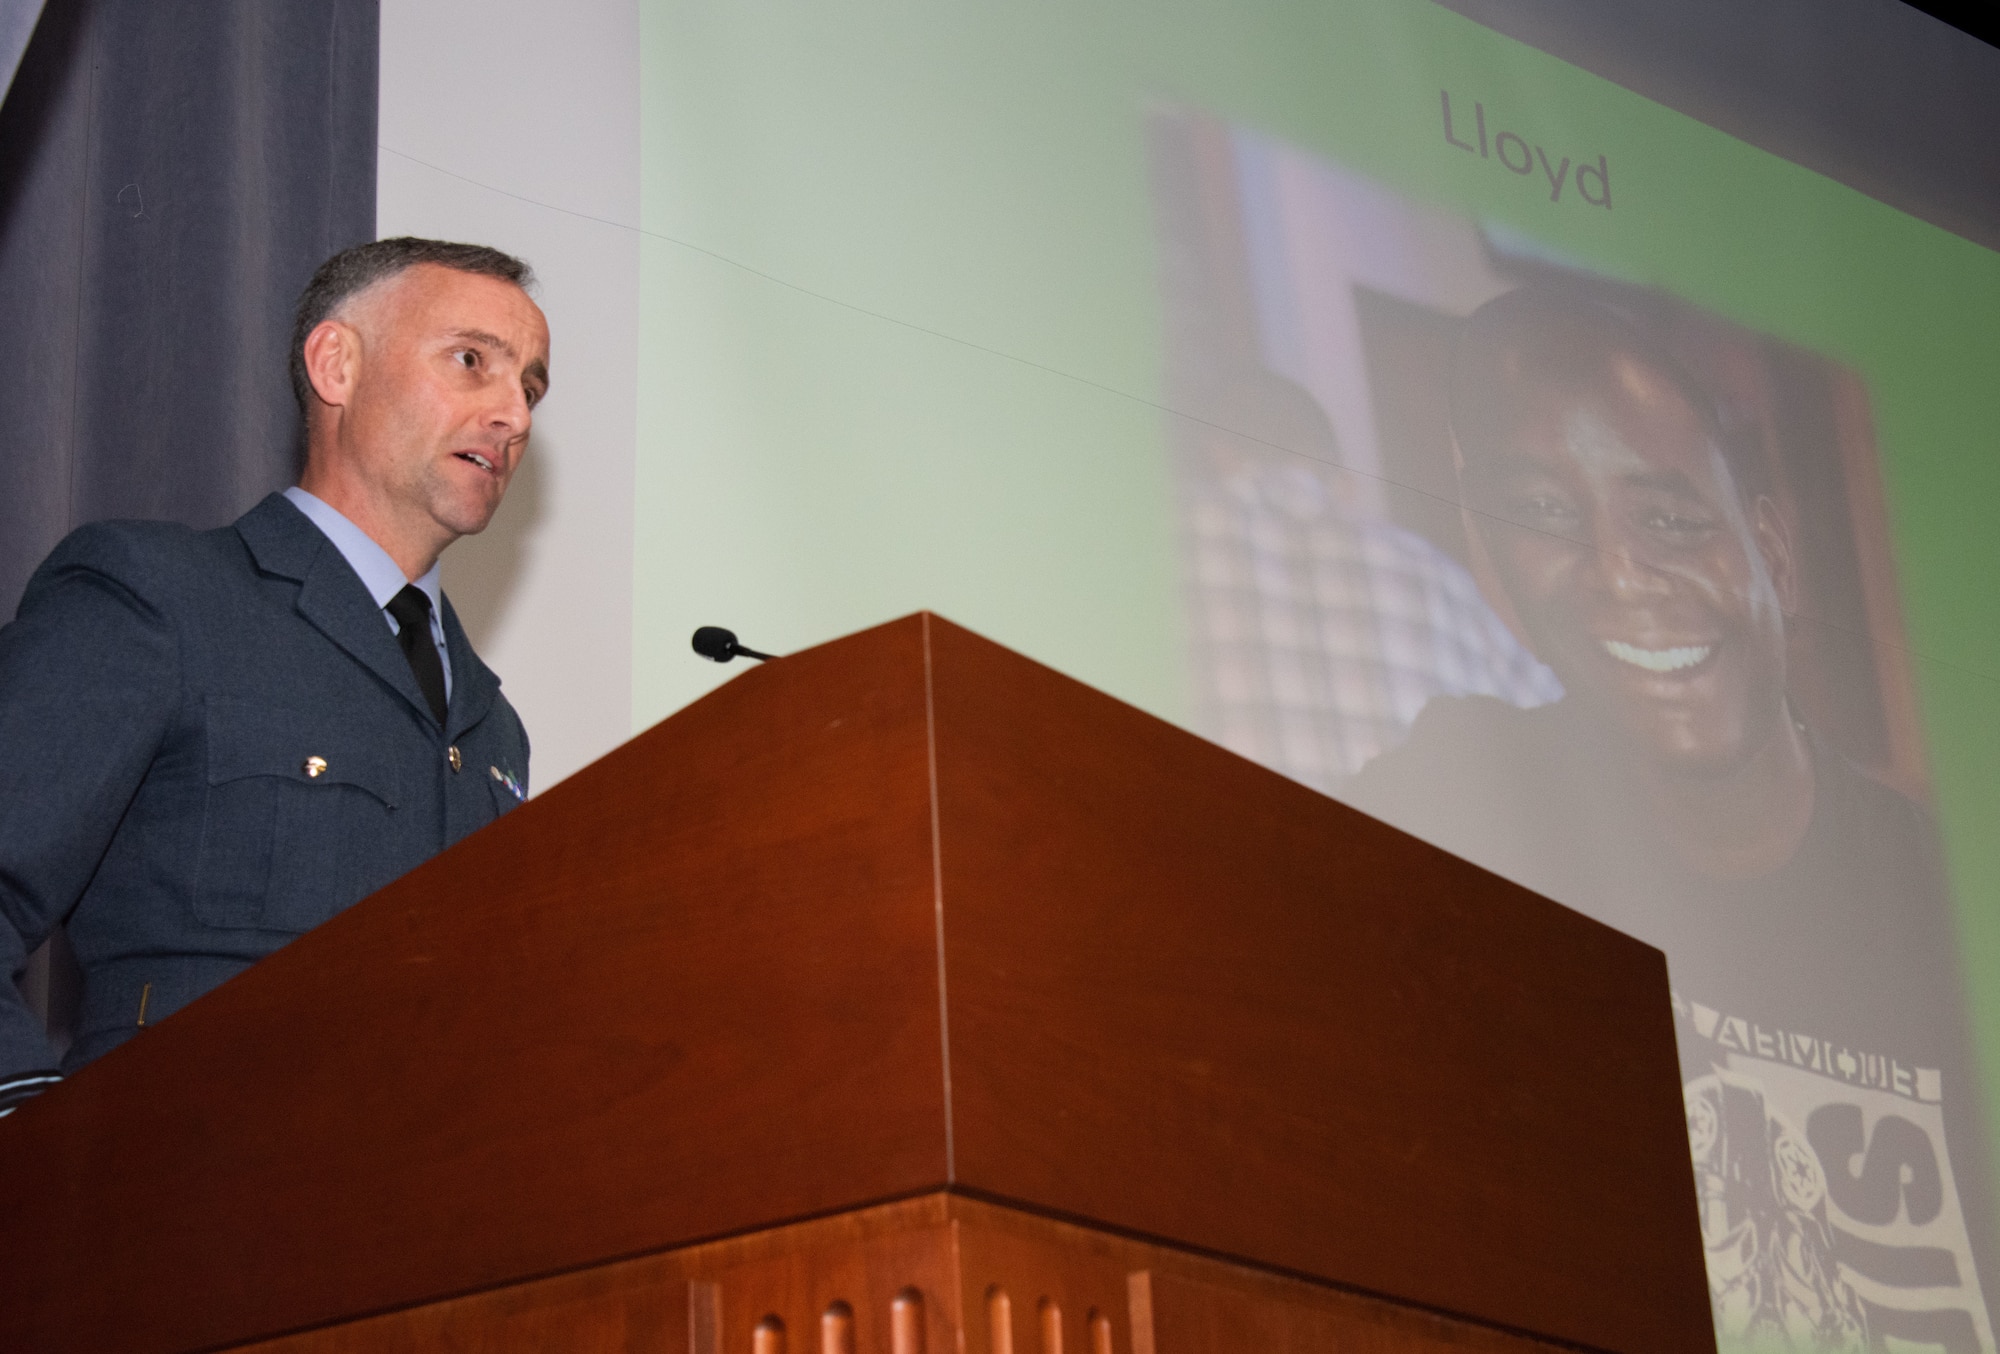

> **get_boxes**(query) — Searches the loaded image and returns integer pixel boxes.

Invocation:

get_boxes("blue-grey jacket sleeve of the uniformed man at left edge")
[0,528,180,1088]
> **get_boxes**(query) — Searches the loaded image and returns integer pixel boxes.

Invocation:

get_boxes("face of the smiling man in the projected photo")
[1464,358,1790,774]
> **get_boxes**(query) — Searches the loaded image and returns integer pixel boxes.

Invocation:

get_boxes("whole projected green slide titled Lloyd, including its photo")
[634,0,2000,1352]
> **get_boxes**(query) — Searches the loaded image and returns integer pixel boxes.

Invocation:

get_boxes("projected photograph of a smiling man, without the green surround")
[1152,112,1994,1352]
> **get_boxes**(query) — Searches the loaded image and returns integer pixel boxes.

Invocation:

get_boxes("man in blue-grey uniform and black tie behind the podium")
[0,238,548,1112]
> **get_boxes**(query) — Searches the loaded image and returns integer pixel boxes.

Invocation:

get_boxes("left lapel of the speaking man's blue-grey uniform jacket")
[236,494,442,728]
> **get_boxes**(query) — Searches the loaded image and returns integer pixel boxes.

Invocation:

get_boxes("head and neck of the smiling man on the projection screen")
[1452,282,1814,878]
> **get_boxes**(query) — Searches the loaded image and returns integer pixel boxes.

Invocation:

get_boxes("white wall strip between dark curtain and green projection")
[376,0,640,790]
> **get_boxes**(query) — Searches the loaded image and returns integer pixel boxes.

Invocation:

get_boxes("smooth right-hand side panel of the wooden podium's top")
[932,622,1712,1350]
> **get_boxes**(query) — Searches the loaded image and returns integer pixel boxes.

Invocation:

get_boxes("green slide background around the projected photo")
[634,0,2000,1184]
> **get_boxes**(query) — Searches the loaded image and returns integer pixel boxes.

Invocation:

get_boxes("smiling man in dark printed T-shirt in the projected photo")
[1342,284,1990,1348]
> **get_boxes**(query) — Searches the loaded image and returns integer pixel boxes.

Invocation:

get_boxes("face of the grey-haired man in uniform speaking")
[340,264,548,536]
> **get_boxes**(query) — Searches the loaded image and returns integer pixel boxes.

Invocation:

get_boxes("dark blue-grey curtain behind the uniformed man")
[0,0,378,1048]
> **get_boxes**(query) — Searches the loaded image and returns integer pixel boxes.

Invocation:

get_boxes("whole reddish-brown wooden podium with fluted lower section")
[0,616,1714,1354]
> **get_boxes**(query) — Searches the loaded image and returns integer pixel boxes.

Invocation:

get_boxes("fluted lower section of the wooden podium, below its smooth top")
[232,1194,1564,1354]
